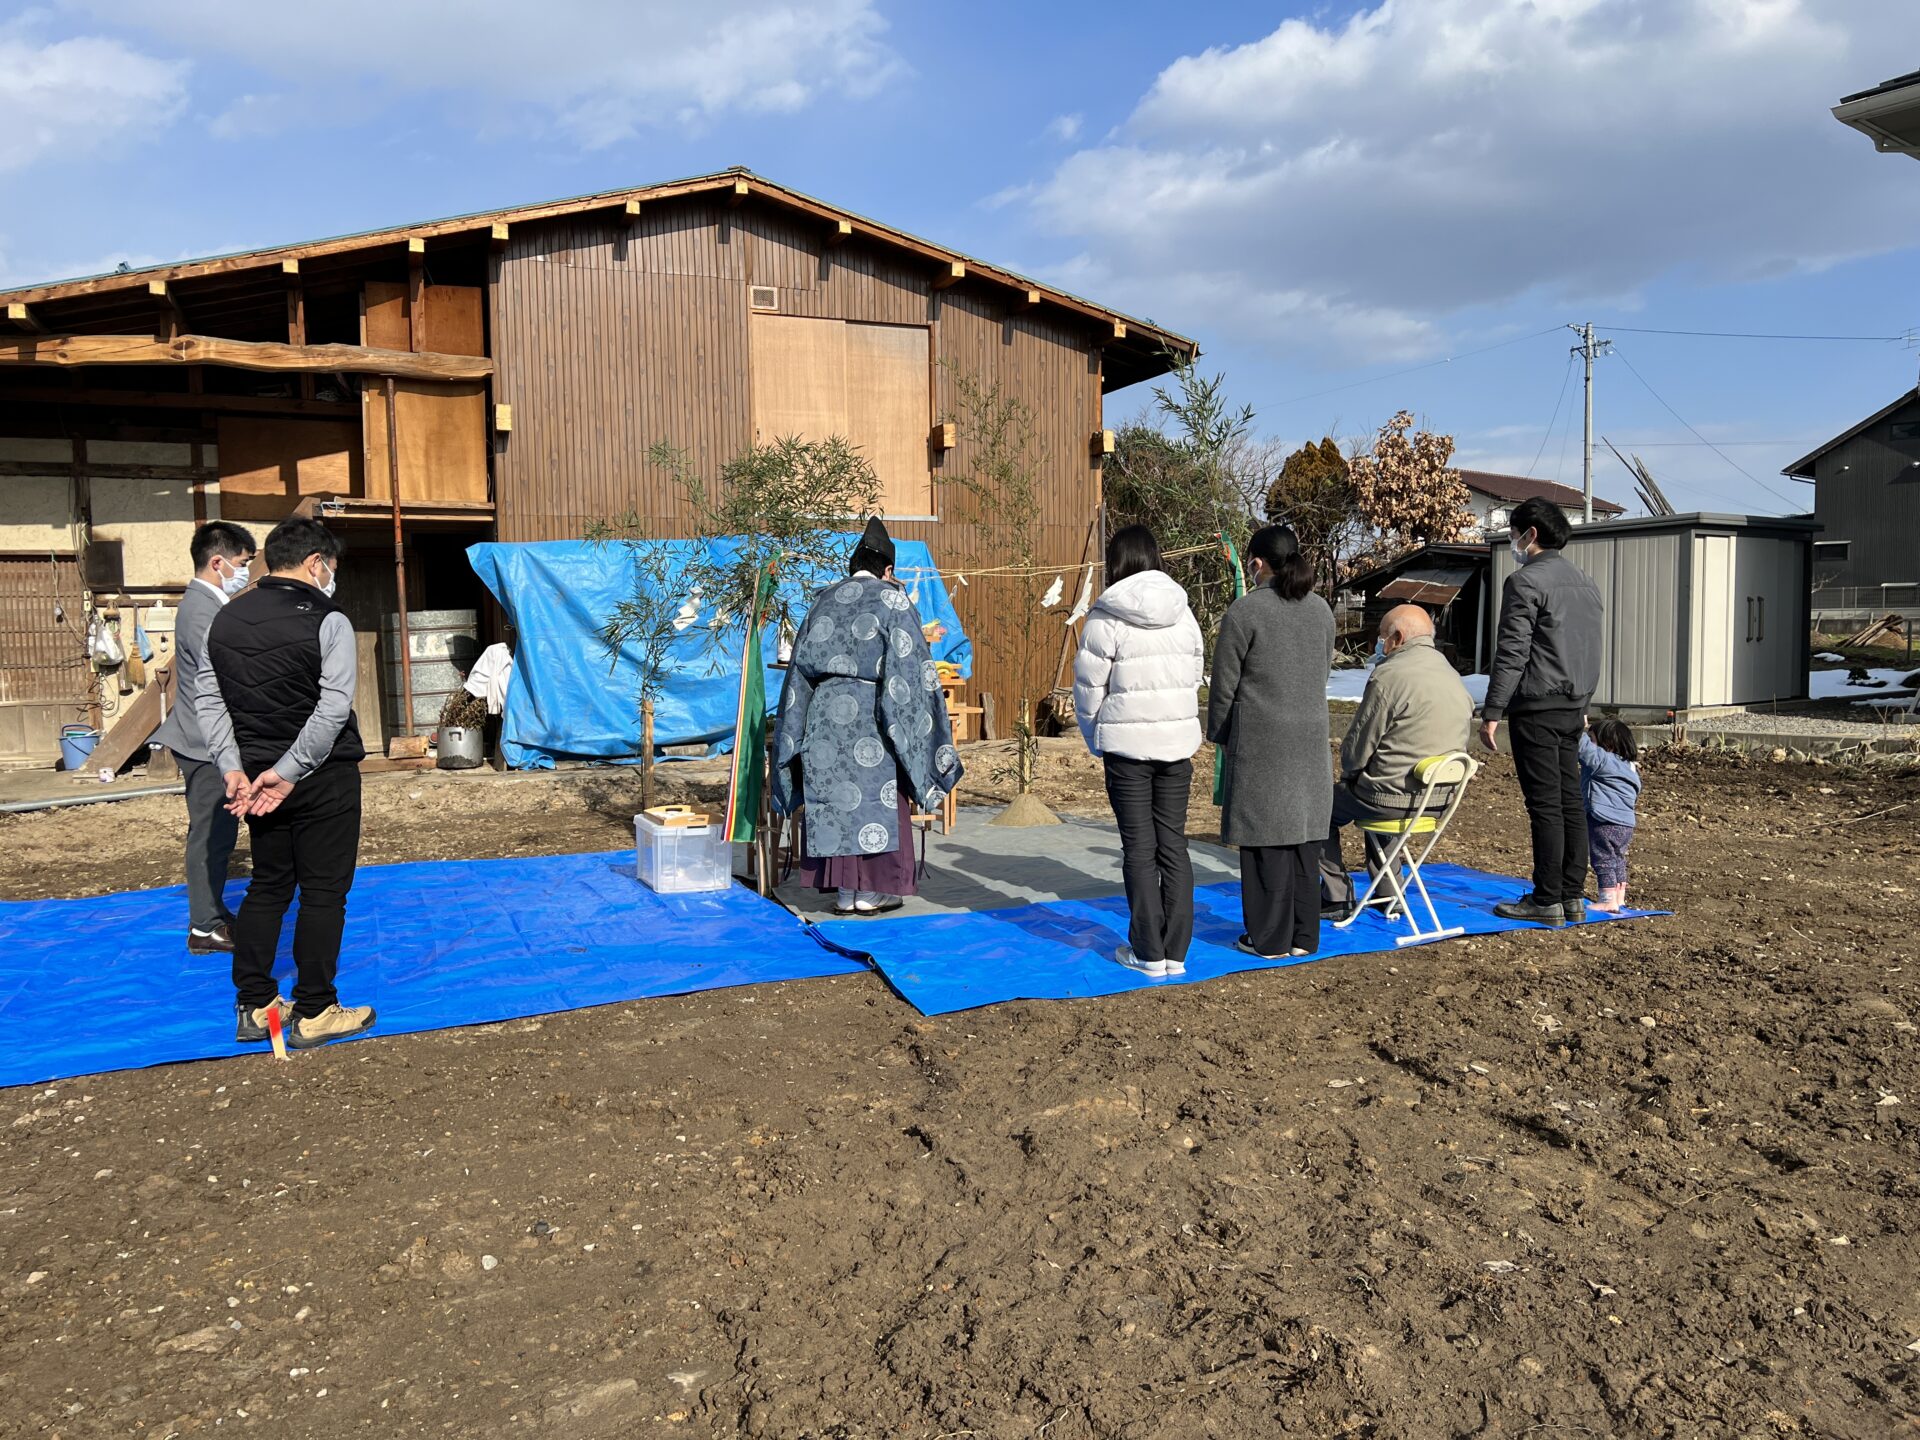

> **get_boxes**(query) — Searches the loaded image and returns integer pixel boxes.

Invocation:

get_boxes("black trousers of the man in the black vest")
[234,762,360,1020]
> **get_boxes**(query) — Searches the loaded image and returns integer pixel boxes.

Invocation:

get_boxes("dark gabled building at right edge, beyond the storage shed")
[1784,390,1920,612]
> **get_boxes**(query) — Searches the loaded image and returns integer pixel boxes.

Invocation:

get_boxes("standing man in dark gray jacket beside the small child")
[1480,497,1601,925]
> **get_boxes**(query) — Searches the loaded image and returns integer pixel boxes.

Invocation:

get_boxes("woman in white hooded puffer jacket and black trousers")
[1073,524,1206,979]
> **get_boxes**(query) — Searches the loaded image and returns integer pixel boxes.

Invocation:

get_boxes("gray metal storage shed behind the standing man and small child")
[1484,515,1818,714]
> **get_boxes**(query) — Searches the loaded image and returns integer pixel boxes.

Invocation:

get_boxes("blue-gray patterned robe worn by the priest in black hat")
[772,574,962,858]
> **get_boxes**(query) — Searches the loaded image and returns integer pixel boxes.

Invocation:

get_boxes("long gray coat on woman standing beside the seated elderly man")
[1206,586,1332,847]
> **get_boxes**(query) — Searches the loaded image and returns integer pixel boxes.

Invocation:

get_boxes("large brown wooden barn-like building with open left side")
[0,171,1194,764]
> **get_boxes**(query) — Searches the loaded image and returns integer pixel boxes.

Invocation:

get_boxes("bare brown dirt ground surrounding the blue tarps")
[0,743,1920,1440]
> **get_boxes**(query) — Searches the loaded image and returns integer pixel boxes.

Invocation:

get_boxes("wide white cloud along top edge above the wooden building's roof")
[77,0,904,148]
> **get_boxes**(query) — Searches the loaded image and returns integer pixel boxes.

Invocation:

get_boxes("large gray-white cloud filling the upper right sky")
[1031,0,1920,363]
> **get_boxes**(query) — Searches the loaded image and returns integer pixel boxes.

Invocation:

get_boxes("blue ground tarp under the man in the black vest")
[0,851,866,1085]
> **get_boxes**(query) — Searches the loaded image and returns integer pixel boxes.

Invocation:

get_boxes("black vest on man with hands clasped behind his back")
[207,576,367,776]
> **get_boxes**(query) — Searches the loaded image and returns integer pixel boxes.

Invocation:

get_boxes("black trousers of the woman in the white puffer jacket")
[1106,755,1194,962]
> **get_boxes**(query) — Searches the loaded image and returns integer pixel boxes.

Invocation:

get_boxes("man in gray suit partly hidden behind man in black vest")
[154,520,253,954]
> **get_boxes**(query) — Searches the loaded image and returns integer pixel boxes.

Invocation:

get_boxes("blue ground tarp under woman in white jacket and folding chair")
[818,864,1659,1016]
